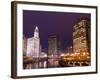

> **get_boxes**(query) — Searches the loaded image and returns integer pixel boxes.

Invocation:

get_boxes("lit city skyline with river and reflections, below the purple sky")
[23,18,91,69]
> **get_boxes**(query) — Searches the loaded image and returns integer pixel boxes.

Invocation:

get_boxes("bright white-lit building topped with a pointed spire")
[27,26,40,57]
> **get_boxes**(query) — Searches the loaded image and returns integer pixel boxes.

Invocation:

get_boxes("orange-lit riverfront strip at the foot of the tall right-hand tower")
[59,56,91,67]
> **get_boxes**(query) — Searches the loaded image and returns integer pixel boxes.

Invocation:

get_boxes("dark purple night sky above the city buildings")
[23,10,90,49]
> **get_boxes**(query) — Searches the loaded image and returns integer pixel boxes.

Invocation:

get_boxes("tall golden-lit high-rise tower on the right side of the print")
[73,18,90,53]
